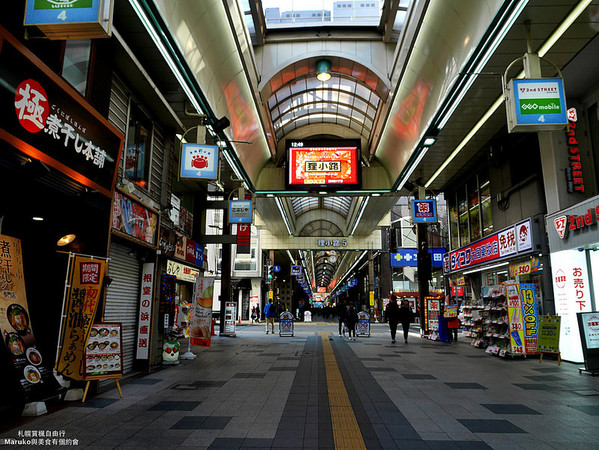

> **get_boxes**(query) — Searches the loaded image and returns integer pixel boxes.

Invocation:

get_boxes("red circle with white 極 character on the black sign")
[15,79,50,133]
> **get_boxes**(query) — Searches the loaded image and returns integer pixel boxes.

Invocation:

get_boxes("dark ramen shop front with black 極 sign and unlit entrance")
[0,24,123,412]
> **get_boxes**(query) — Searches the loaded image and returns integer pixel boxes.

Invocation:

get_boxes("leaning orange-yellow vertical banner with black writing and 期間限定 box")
[56,256,106,380]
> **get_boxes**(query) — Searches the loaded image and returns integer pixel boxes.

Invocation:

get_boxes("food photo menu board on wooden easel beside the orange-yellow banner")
[85,322,123,378]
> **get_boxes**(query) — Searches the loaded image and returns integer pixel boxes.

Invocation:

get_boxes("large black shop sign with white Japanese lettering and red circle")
[0,27,123,197]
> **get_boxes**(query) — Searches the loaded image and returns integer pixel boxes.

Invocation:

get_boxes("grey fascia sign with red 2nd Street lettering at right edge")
[546,196,599,252]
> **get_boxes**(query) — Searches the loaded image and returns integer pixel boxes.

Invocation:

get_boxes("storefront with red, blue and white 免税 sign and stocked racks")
[444,218,544,356]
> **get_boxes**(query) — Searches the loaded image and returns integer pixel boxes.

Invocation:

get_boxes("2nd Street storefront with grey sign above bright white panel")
[547,196,599,363]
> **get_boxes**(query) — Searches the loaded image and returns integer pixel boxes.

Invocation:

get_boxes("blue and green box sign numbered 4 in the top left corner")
[24,0,114,39]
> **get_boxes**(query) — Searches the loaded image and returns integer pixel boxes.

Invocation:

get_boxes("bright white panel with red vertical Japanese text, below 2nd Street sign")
[550,250,591,363]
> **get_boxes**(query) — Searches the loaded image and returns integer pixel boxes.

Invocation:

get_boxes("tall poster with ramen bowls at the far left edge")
[0,235,54,401]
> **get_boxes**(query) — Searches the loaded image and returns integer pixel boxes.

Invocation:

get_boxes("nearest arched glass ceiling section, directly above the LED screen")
[263,57,389,140]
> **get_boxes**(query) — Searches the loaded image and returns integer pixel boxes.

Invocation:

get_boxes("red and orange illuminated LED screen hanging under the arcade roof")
[287,140,361,191]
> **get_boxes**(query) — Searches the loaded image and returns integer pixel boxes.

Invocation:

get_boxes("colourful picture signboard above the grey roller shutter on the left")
[112,191,159,247]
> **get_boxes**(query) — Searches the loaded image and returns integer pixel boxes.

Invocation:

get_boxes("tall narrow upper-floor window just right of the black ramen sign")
[125,103,152,188]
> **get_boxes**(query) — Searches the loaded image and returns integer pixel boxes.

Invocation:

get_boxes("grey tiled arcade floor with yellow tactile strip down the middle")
[0,323,599,450]
